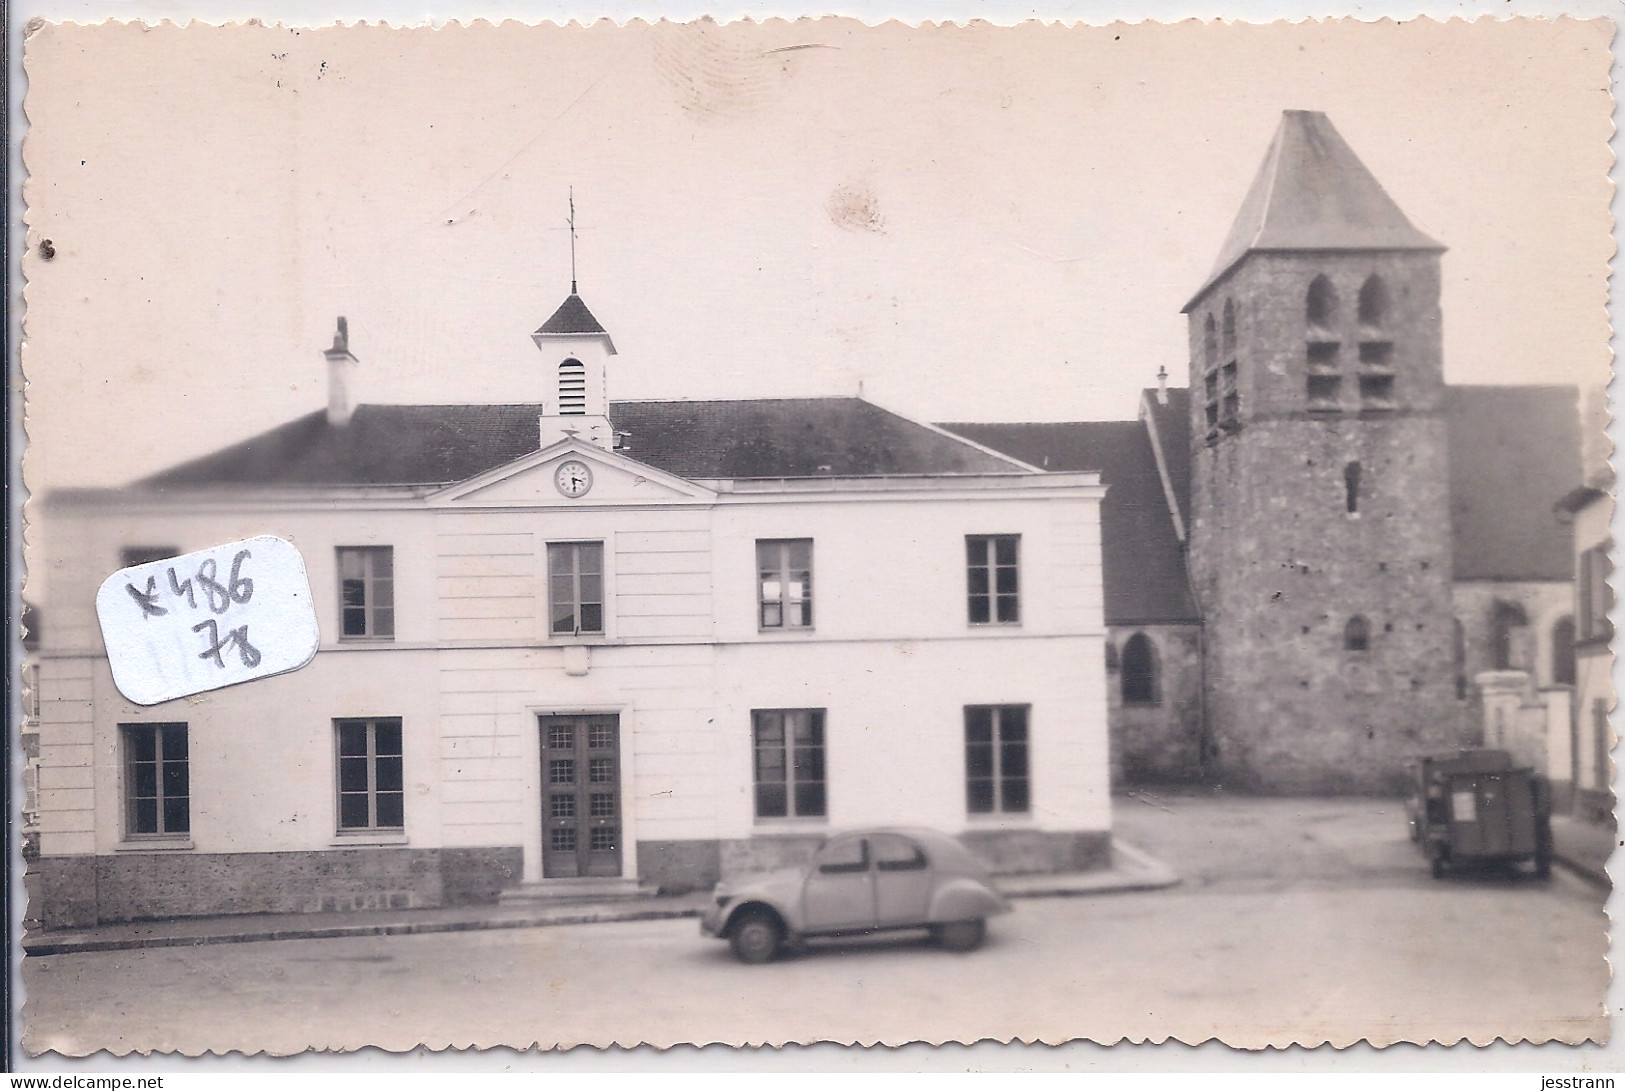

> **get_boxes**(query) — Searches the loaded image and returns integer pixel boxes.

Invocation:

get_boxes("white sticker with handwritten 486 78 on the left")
[96,535,322,704]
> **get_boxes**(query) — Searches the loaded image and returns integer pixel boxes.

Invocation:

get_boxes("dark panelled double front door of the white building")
[540,715,621,880]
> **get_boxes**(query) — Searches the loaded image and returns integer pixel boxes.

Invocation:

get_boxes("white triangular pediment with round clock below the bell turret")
[429,439,715,507]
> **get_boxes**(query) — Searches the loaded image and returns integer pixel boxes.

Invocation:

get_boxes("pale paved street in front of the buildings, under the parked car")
[23,797,1607,1054]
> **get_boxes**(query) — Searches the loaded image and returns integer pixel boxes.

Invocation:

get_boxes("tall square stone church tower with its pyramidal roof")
[1185,111,1463,792]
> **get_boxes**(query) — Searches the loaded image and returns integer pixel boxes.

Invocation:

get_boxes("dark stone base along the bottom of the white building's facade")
[29,829,1112,928]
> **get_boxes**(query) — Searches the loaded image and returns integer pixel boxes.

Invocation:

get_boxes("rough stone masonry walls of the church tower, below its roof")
[1191,254,1463,793]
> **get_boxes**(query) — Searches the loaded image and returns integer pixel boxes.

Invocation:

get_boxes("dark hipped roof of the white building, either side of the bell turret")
[141,398,1022,488]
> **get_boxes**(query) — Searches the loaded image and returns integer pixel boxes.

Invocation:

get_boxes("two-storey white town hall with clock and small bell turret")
[36,285,1110,927]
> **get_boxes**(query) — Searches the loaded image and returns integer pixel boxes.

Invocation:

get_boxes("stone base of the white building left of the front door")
[31,845,523,928]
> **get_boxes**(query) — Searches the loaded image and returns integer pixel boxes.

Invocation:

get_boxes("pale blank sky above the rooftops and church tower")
[24,20,1612,489]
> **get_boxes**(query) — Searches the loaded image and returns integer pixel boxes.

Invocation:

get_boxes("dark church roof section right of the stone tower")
[1445,387,1581,580]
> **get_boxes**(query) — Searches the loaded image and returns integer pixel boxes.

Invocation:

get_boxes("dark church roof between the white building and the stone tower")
[943,419,1199,624]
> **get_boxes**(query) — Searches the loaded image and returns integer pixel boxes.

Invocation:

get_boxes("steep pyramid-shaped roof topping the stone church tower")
[1186,111,1445,311]
